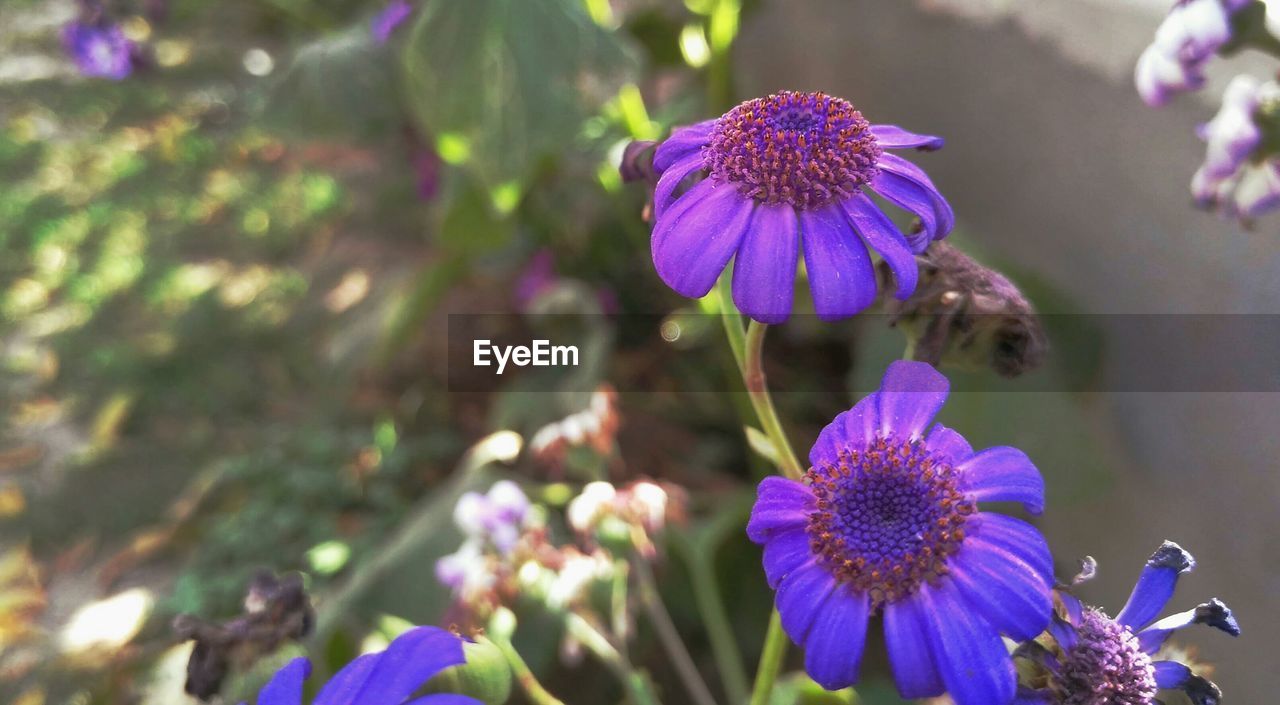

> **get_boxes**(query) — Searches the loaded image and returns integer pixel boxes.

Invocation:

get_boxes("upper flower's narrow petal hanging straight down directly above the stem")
[733,205,800,324]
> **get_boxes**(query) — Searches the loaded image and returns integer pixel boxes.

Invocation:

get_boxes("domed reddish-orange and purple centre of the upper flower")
[703,91,881,209]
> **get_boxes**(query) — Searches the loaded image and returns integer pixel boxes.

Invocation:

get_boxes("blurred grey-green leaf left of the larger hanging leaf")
[265,23,404,141]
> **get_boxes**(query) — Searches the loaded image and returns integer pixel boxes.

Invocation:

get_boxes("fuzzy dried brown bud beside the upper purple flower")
[879,242,1048,377]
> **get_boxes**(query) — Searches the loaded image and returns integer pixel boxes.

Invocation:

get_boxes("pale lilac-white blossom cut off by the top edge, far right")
[1134,0,1249,107]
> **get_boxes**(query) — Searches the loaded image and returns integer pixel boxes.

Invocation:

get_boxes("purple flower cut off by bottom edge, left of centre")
[244,627,481,705]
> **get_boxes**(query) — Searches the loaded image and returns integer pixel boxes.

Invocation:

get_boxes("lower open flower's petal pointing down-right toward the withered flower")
[948,543,1053,641]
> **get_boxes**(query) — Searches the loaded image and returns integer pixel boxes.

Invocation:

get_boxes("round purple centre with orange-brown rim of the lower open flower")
[806,436,977,610]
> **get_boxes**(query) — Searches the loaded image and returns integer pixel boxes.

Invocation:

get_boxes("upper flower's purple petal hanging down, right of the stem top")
[800,205,876,321]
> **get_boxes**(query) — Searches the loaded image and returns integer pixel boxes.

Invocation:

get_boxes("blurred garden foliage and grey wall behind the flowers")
[0,0,1280,705]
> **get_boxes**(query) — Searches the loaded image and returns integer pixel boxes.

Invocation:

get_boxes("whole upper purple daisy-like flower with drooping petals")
[652,91,955,324]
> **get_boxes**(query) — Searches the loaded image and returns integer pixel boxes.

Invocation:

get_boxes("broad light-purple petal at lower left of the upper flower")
[652,179,755,298]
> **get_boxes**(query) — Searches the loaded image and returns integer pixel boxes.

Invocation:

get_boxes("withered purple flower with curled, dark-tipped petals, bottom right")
[1016,541,1240,705]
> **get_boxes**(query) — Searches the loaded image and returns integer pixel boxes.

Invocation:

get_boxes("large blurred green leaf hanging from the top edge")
[402,0,635,189]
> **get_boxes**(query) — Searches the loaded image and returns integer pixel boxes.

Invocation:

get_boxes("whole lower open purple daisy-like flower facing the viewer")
[746,361,1052,705]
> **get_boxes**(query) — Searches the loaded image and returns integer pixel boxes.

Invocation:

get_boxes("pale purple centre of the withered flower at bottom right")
[1059,610,1156,705]
